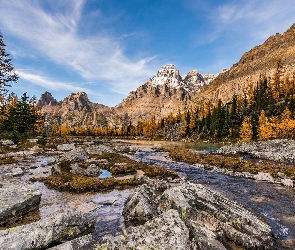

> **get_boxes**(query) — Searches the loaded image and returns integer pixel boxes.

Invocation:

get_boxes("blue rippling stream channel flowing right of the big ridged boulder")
[129,142,295,249]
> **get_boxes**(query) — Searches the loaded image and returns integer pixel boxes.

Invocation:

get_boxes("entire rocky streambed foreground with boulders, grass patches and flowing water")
[0,138,295,249]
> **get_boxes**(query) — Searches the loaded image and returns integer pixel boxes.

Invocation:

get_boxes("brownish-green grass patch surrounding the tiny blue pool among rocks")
[31,153,178,193]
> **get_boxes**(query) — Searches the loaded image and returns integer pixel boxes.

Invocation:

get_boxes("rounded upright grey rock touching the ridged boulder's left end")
[122,184,158,226]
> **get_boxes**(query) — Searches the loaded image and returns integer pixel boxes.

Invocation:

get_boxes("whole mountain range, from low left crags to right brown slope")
[37,24,295,127]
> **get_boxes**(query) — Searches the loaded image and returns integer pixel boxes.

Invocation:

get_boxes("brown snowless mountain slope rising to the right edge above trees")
[196,24,295,103]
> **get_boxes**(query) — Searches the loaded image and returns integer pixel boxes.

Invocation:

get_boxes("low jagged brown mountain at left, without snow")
[37,92,123,128]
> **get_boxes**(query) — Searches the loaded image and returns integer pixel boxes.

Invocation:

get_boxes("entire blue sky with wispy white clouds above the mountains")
[0,0,295,106]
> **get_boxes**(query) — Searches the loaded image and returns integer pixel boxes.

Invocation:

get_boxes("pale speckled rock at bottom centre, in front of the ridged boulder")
[97,210,190,250]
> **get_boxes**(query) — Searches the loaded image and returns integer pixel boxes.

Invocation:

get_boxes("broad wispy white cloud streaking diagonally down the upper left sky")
[0,0,156,94]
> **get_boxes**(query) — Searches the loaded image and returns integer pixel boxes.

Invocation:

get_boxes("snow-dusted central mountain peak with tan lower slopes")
[116,64,216,122]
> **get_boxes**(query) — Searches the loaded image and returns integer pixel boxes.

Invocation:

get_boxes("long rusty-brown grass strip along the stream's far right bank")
[165,148,295,179]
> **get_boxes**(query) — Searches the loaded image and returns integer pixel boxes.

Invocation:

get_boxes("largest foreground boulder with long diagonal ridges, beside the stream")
[159,183,273,249]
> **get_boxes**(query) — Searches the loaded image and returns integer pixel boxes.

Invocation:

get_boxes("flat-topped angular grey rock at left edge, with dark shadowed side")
[0,184,41,227]
